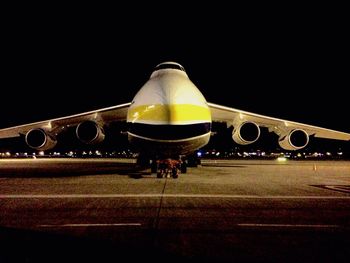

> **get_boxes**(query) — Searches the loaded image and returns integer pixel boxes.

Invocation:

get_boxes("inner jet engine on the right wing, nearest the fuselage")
[232,121,260,145]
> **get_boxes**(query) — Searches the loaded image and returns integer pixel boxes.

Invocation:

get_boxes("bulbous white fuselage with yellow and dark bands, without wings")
[127,62,211,157]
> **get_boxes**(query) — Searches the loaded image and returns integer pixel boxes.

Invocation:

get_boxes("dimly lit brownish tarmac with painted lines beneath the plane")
[0,158,350,262]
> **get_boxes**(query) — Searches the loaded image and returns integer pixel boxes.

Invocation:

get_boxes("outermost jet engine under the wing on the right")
[278,129,309,150]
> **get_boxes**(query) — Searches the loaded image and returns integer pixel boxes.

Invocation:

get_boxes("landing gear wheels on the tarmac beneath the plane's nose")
[151,158,187,179]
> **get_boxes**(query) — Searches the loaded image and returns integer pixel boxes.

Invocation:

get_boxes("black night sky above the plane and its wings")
[0,9,350,135]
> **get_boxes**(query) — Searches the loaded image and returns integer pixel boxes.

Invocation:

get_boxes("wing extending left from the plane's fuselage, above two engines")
[0,103,131,139]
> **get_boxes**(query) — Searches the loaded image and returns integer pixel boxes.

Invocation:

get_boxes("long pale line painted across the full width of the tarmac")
[0,194,350,200]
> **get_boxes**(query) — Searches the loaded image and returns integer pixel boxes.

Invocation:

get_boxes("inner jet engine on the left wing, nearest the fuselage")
[75,121,105,144]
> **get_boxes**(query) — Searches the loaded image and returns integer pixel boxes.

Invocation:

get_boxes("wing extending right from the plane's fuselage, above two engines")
[208,103,350,141]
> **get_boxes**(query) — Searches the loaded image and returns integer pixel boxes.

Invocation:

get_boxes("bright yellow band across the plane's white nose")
[127,104,211,124]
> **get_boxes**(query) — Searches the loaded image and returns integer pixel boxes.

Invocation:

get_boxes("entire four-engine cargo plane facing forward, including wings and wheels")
[0,61,350,178]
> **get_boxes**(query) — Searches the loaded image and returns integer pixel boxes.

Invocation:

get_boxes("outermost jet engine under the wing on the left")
[25,128,57,151]
